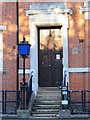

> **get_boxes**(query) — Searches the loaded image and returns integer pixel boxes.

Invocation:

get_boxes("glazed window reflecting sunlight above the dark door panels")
[40,29,63,50]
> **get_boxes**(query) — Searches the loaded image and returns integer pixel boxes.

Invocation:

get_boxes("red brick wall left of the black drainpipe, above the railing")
[2,2,16,89]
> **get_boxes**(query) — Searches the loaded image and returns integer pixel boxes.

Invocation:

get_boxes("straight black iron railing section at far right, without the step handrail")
[68,90,90,114]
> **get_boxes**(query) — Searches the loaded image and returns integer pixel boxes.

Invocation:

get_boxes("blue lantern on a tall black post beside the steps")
[18,36,31,109]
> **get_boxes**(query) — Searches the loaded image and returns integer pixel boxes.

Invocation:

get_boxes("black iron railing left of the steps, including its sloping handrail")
[0,75,33,114]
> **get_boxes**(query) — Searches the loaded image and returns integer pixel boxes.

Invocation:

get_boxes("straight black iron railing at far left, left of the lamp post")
[0,90,19,114]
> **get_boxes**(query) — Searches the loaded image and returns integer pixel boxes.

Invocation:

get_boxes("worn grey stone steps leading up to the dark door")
[31,87,61,118]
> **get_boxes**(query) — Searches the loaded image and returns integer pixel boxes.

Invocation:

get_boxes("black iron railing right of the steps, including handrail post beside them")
[61,71,90,114]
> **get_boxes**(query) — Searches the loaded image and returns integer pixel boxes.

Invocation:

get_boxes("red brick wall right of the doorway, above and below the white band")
[68,2,89,90]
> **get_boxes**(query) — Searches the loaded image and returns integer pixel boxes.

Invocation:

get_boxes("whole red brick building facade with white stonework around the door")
[0,1,90,92]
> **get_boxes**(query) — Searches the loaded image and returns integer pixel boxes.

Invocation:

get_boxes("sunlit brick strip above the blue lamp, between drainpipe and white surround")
[19,2,30,42]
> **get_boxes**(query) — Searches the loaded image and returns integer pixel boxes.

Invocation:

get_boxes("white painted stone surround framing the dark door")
[26,2,72,93]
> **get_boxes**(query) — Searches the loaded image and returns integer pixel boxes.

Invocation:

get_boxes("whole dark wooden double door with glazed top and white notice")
[39,28,63,87]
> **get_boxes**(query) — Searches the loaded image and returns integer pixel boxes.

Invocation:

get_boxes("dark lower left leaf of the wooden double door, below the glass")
[39,50,51,86]
